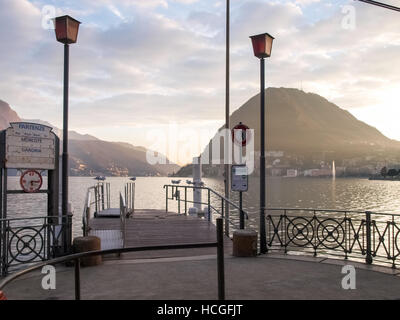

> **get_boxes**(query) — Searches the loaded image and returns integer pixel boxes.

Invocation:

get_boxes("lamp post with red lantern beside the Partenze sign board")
[54,16,80,245]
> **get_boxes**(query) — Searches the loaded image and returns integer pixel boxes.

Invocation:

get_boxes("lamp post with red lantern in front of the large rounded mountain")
[250,33,274,253]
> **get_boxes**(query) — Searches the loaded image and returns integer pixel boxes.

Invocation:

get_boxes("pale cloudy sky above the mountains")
[0,0,400,164]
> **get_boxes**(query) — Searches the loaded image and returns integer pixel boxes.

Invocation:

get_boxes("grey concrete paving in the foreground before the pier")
[4,254,400,300]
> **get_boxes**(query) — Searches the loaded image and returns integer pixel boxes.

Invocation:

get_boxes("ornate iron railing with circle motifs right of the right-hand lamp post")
[266,208,400,268]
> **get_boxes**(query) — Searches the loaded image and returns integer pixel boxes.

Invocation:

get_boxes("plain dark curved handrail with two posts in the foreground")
[0,218,225,300]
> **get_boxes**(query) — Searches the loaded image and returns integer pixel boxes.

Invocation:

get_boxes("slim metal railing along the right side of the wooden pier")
[164,185,249,237]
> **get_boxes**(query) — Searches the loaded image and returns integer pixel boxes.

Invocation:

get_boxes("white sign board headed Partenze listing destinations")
[5,122,56,170]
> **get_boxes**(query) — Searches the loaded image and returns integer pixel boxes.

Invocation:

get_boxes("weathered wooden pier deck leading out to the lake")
[89,209,232,259]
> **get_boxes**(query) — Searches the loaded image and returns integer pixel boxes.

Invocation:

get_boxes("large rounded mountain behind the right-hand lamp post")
[177,88,400,176]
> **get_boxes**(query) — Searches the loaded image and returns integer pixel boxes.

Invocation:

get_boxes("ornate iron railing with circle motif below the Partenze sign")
[0,215,72,276]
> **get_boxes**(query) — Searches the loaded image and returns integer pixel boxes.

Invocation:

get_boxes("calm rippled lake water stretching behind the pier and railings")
[8,177,400,236]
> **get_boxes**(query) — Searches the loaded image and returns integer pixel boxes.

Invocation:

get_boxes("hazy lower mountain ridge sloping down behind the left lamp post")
[0,100,180,176]
